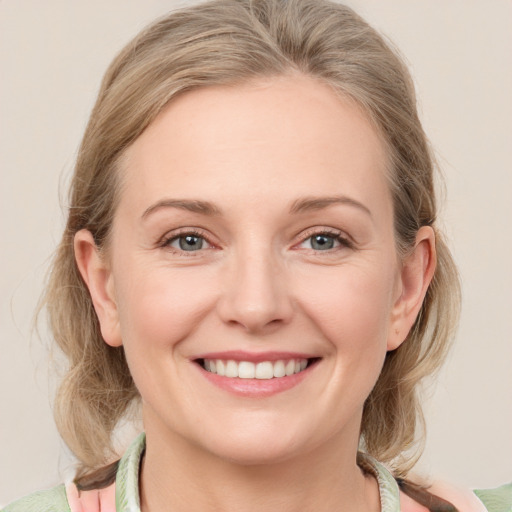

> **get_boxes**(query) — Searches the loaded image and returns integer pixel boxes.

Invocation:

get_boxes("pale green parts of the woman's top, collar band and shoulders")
[0,434,512,512]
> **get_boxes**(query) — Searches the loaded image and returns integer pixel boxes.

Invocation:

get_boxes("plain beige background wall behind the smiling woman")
[0,0,512,504]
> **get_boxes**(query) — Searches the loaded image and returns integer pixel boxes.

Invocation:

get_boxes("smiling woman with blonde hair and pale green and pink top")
[6,0,510,511]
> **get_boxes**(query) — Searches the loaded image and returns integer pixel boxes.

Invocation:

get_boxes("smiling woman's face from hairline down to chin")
[81,76,424,463]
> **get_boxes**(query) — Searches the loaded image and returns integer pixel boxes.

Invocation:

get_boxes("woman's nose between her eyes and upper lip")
[218,247,293,334]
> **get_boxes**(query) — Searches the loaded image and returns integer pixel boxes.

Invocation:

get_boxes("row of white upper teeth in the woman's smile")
[203,359,308,380]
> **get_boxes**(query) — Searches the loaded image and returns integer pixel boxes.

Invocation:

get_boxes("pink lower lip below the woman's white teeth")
[197,362,317,398]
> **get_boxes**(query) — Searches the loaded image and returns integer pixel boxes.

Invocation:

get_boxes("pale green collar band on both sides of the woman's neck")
[116,433,400,512]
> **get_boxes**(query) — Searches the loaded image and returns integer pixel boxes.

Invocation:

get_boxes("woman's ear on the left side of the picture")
[74,229,122,347]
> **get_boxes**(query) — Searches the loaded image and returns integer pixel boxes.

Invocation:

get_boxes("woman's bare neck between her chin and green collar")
[141,418,380,512]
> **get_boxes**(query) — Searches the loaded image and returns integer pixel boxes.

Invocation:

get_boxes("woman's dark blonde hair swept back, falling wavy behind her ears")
[44,0,460,484]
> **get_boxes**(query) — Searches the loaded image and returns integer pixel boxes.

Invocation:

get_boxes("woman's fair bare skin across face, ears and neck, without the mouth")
[75,75,435,512]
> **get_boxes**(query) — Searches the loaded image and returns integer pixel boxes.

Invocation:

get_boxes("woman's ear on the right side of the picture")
[387,226,436,350]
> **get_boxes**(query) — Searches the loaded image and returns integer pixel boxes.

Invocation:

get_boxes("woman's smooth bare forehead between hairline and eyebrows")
[121,75,387,210]
